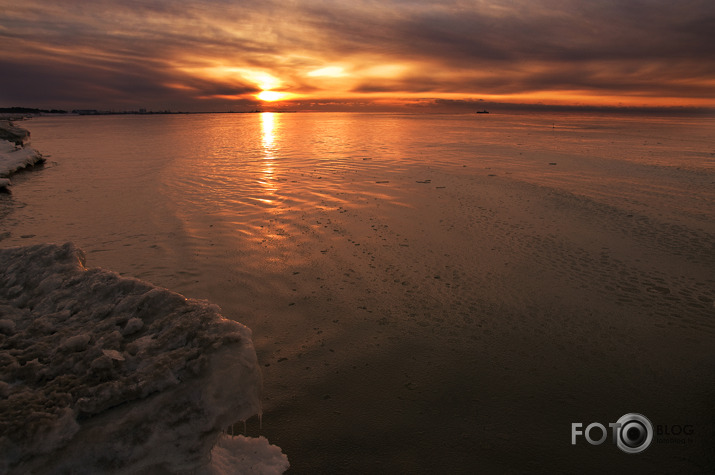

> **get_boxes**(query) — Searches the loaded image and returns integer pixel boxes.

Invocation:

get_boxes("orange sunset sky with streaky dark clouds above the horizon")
[0,0,715,112]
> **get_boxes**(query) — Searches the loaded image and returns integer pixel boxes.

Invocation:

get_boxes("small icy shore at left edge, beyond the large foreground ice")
[0,120,45,190]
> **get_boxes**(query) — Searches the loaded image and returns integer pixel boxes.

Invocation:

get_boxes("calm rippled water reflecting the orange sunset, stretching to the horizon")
[0,113,715,473]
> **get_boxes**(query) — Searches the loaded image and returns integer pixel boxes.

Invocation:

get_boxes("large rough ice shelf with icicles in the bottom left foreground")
[0,243,288,474]
